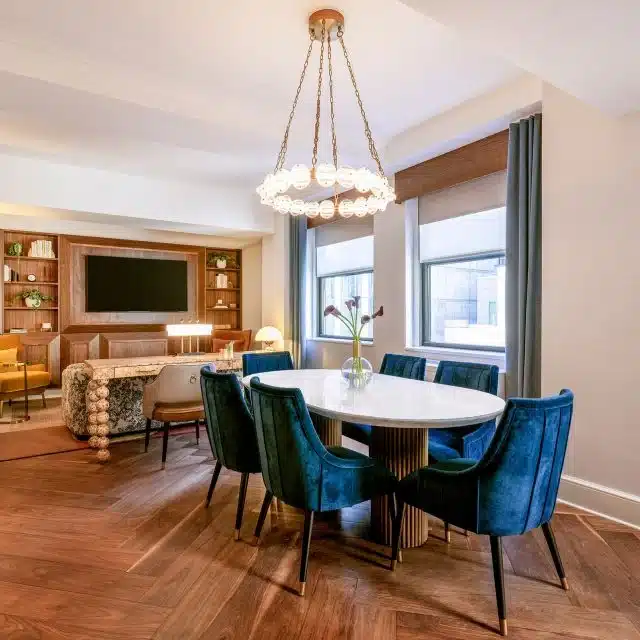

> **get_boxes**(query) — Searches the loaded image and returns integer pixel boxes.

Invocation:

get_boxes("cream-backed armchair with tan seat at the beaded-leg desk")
[142,363,204,469]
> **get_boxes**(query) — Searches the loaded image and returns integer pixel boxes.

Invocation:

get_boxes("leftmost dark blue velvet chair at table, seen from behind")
[200,366,260,540]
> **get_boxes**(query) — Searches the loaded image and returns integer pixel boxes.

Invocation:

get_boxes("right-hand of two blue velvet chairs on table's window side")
[429,360,498,462]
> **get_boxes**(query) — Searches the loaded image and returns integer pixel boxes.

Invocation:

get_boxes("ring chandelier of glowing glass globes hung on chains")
[256,9,396,219]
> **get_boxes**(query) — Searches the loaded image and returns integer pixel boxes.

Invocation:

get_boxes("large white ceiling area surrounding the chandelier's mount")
[0,0,521,189]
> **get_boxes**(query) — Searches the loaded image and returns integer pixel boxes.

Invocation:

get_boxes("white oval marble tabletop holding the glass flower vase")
[242,369,505,429]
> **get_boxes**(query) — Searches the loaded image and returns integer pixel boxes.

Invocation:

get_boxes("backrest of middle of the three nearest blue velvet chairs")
[251,378,327,510]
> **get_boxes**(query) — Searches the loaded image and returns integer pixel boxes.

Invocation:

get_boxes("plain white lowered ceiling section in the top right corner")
[404,0,640,116]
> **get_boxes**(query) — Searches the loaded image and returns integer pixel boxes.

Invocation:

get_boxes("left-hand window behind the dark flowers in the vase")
[316,231,373,340]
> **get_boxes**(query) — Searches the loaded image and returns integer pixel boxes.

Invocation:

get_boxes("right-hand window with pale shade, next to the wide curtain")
[420,207,505,351]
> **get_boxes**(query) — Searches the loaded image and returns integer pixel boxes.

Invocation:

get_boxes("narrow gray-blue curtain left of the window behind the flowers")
[289,216,307,368]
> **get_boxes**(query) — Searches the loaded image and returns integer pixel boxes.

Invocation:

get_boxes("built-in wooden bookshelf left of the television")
[1,231,60,333]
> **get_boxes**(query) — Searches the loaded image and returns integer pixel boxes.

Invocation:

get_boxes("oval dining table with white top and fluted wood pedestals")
[242,369,505,548]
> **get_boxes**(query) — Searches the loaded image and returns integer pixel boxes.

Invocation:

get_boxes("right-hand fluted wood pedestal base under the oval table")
[369,427,429,548]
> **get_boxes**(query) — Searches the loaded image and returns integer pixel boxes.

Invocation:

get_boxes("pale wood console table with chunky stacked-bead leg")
[85,353,242,462]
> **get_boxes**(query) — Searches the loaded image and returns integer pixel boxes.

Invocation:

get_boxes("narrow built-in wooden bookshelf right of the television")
[205,249,242,329]
